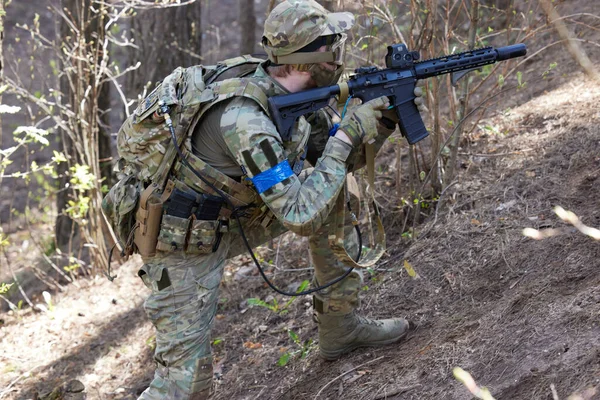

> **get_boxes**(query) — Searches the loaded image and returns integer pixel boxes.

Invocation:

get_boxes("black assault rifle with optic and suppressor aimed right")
[269,44,527,144]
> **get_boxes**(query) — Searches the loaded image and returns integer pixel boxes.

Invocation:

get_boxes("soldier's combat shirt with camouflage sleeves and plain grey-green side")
[192,63,352,236]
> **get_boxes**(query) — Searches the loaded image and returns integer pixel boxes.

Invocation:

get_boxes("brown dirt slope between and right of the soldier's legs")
[206,73,600,399]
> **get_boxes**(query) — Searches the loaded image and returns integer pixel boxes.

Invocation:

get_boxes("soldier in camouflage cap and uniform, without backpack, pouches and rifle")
[139,0,420,399]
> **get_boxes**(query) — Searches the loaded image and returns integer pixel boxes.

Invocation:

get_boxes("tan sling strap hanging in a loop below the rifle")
[329,140,386,268]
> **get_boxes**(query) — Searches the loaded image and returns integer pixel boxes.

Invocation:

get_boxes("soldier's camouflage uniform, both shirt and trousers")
[139,0,408,399]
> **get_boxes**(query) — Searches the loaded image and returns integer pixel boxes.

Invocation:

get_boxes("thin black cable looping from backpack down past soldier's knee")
[160,103,354,297]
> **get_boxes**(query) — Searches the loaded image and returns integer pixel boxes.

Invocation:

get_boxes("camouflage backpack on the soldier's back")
[102,56,267,257]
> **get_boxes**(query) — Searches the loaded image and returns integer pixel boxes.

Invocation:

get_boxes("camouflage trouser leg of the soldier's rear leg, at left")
[138,239,229,400]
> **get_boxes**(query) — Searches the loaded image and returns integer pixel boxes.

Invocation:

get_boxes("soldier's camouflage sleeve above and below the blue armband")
[221,64,352,236]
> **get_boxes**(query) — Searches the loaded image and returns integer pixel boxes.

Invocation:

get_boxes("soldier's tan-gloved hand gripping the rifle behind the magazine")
[339,96,393,147]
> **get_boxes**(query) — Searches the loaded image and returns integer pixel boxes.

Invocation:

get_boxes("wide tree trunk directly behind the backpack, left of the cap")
[126,1,202,96]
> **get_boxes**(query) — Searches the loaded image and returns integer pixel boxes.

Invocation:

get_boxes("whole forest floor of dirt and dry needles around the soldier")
[0,0,600,400]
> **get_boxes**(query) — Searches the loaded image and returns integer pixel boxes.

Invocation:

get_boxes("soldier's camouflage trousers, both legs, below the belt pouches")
[138,192,362,400]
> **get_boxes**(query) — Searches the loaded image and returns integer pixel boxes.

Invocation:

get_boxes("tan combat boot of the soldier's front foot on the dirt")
[315,311,413,360]
